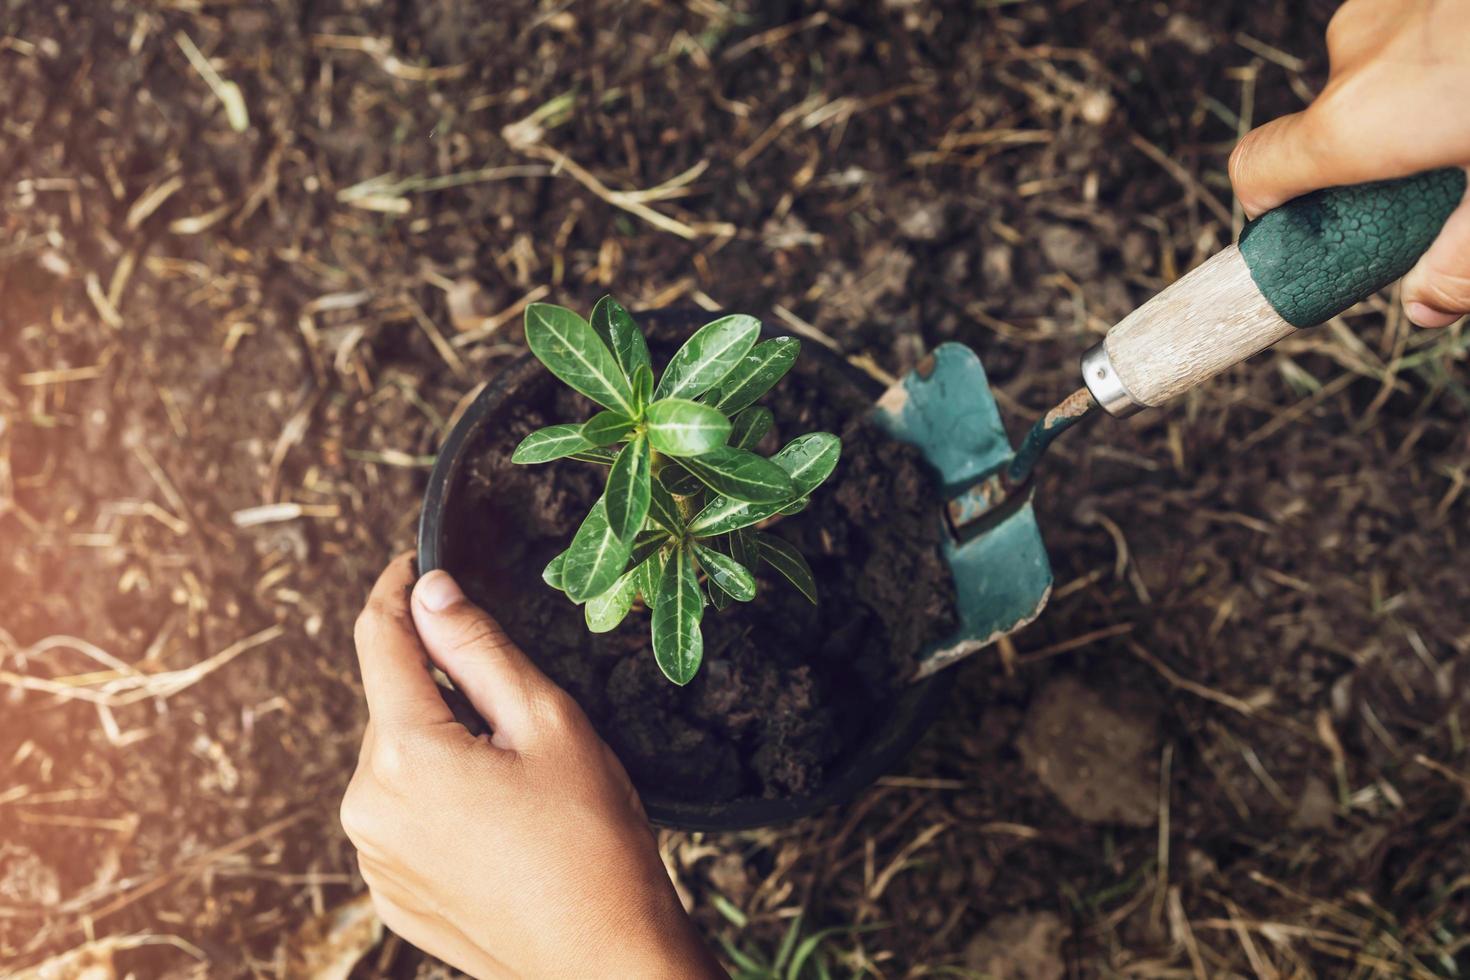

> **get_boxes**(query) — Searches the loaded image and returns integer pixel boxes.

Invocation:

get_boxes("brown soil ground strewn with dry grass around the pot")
[0,0,1470,977]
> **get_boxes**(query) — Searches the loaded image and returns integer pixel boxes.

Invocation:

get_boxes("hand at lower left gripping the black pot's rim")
[341,555,725,979]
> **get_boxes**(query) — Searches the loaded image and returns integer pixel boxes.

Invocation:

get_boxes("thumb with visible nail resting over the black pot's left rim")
[413,570,554,748]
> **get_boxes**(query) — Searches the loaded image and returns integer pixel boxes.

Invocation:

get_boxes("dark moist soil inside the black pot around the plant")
[432,320,956,802]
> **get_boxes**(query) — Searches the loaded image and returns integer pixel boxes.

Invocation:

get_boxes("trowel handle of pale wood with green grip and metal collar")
[1082,167,1466,416]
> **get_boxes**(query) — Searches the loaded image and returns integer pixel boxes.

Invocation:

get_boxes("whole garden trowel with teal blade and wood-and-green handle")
[873,167,1466,679]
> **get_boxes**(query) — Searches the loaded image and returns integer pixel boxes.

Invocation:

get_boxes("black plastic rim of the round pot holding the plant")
[419,310,948,830]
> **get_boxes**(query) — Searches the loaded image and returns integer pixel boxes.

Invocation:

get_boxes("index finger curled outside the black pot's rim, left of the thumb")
[353,555,454,729]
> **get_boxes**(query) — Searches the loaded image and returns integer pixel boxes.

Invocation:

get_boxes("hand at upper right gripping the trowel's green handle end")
[1230,0,1470,326]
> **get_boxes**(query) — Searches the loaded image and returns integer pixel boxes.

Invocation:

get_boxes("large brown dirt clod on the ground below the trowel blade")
[1017,676,1158,827]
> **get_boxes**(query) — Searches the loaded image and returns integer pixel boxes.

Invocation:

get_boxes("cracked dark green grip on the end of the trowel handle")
[1239,167,1466,326]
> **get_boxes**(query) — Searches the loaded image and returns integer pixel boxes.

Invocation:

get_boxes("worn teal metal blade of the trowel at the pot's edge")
[873,344,1051,677]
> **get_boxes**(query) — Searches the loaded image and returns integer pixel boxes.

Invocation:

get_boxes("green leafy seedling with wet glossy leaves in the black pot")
[512,297,842,685]
